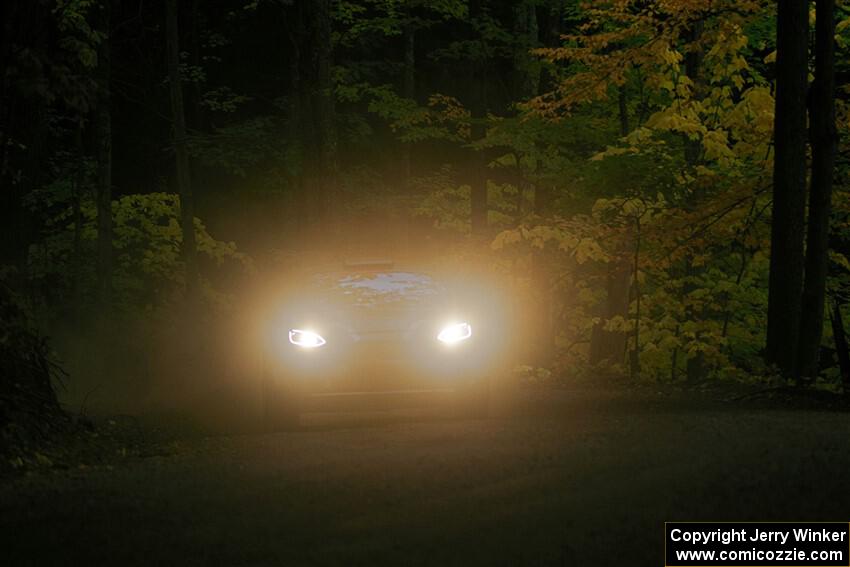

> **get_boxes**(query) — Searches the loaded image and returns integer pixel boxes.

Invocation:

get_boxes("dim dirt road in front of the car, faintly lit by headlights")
[0,392,850,566]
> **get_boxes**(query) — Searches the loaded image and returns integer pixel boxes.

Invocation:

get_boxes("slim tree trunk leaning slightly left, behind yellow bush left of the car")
[165,0,198,301]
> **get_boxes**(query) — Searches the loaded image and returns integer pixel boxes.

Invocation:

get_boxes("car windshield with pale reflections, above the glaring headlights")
[316,271,441,307]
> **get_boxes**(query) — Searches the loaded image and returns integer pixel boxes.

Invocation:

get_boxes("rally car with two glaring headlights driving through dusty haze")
[263,261,500,429]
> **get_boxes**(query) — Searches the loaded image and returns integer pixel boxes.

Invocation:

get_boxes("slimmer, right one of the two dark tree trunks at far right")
[797,0,838,380]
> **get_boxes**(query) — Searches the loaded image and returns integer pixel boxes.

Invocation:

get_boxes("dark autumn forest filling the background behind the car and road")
[0,0,850,466]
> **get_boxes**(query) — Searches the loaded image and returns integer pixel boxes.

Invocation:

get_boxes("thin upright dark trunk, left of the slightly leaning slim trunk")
[94,1,112,315]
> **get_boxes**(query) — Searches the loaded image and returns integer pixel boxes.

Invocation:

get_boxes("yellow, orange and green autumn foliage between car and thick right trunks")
[454,0,800,379]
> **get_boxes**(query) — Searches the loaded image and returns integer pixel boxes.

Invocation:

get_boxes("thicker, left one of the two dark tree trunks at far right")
[765,0,809,376]
